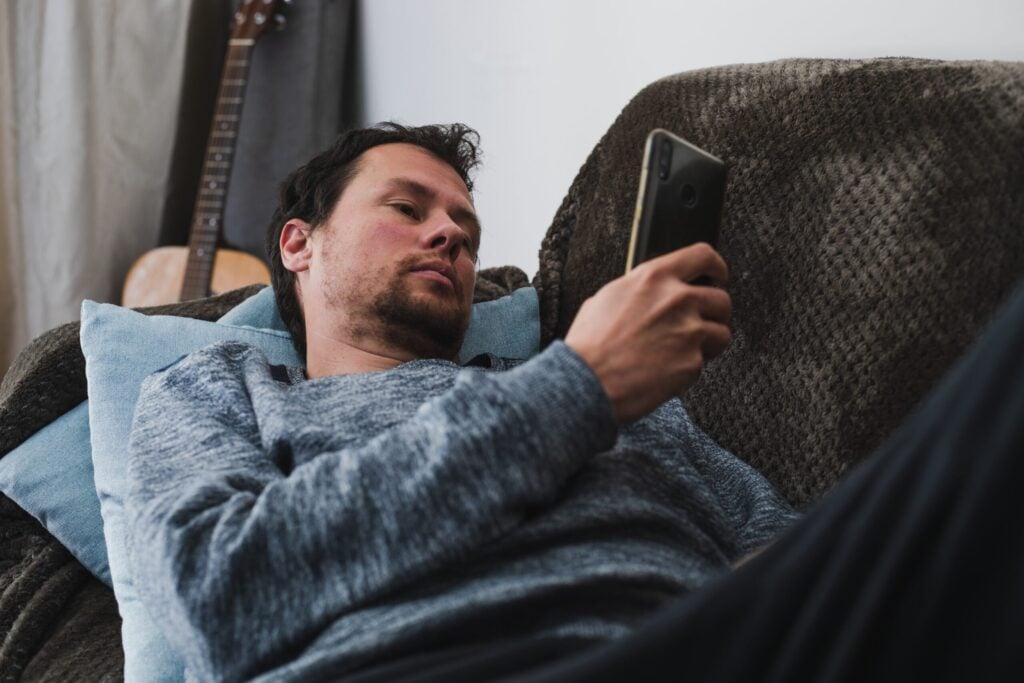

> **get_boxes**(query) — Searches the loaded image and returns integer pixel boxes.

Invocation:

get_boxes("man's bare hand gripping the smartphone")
[565,243,732,423]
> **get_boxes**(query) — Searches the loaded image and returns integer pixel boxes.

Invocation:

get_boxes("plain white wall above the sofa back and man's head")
[360,0,1024,276]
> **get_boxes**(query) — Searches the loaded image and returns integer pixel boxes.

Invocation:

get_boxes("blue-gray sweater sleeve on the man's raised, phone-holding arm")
[119,342,617,680]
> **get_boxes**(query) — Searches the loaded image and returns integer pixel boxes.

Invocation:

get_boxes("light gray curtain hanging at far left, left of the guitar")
[0,0,193,376]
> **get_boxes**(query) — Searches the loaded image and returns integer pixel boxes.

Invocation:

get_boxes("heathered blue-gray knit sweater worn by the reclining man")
[126,342,795,681]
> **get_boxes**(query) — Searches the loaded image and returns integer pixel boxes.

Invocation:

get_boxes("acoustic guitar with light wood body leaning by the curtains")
[121,0,288,308]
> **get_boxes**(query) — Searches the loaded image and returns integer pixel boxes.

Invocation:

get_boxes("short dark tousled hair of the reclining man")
[265,122,480,357]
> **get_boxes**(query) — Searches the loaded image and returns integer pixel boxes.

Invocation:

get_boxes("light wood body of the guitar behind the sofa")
[121,247,270,308]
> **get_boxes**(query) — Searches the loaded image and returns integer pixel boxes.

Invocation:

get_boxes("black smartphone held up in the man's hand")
[626,128,726,272]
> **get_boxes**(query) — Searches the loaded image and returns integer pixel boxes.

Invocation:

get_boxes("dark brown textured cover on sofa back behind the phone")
[535,58,1024,506]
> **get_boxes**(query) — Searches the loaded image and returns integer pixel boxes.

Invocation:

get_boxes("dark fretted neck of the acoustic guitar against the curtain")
[180,38,255,301]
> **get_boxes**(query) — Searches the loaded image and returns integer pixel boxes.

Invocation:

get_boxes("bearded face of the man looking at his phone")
[302,143,480,359]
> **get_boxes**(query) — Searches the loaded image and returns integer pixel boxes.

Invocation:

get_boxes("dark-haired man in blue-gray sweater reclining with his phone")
[126,125,1021,683]
